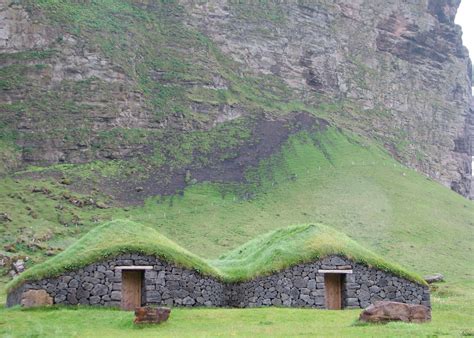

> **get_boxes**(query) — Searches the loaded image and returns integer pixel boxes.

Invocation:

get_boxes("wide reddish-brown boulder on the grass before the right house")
[359,301,431,323]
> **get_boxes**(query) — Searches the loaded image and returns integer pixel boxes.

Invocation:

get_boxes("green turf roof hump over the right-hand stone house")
[209,223,427,285]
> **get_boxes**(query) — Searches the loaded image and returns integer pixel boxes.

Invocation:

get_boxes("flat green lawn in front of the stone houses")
[0,283,474,337]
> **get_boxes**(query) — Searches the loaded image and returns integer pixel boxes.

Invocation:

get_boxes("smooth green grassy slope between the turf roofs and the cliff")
[0,129,474,288]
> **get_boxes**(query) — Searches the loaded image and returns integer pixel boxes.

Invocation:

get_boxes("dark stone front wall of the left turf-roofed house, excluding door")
[7,254,224,306]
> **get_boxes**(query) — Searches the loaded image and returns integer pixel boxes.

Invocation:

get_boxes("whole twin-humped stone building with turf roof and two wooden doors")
[7,221,430,309]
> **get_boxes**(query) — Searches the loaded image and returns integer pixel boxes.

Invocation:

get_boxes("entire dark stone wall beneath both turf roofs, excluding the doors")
[7,254,430,308]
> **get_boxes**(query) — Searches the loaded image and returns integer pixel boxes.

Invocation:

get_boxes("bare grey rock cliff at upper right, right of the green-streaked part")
[180,0,472,195]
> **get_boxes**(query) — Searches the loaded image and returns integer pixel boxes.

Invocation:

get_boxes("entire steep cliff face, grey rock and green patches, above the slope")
[0,0,474,196]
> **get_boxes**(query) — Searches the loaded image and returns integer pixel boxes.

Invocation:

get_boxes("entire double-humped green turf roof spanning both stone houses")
[7,220,425,290]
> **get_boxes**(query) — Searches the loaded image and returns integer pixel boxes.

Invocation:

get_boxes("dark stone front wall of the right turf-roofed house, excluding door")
[226,256,430,308]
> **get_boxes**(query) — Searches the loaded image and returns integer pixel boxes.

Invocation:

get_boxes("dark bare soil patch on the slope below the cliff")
[101,113,329,205]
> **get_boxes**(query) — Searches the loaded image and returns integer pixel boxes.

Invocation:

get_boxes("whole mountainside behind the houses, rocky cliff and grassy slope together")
[0,0,474,322]
